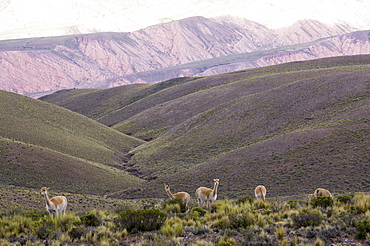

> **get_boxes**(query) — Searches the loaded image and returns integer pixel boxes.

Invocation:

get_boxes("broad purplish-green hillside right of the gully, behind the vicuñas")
[41,55,370,198]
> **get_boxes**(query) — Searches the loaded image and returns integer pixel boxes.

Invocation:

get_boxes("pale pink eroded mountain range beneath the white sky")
[0,17,360,94]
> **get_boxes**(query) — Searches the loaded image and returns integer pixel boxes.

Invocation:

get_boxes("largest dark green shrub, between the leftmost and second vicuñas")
[116,209,167,233]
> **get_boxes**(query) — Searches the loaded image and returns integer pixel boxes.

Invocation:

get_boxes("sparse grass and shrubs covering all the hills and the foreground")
[0,58,370,245]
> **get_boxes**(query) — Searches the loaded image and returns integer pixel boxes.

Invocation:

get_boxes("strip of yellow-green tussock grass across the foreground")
[0,194,370,245]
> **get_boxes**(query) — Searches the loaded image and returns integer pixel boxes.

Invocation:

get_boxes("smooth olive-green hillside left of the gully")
[0,91,143,195]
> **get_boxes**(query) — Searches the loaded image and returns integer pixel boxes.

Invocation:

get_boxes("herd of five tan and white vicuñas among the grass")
[40,179,333,217]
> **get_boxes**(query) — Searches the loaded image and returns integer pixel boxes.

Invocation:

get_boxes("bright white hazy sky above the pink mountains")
[0,0,370,39]
